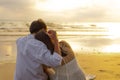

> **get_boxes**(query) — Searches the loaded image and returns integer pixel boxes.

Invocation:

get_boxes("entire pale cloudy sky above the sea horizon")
[0,0,120,22]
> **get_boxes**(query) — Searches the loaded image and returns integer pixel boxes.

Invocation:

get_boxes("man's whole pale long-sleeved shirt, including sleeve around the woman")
[15,35,62,80]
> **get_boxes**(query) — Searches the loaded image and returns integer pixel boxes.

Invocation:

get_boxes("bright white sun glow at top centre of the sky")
[35,0,90,12]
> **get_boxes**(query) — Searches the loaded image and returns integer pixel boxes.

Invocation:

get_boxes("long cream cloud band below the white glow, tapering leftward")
[39,7,107,22]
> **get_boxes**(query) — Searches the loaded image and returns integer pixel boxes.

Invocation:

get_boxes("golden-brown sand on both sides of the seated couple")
[0,53,120,80]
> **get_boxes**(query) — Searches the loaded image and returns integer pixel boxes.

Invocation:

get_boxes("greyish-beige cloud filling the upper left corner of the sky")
[0,0,35,20]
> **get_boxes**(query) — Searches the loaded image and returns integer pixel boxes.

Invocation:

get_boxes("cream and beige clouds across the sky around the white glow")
[0,0,120,22]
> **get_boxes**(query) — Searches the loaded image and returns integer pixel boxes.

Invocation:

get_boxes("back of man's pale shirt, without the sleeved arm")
[15,35,47,80]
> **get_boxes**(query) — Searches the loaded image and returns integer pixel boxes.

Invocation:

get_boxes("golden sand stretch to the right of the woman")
[76,54,120,80]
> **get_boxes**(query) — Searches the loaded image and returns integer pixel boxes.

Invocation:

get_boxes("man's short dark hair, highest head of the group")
[29,19,47,34]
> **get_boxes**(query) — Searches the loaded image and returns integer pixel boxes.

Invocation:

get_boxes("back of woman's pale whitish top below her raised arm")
[51,59,86,80]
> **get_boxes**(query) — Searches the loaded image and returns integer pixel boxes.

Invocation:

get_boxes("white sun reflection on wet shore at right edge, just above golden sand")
[103,44,120,52]
